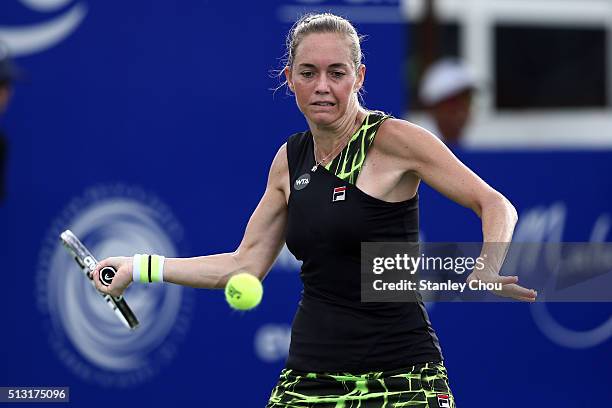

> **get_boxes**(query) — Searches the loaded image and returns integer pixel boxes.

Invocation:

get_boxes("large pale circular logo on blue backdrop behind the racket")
[36,185,194,388]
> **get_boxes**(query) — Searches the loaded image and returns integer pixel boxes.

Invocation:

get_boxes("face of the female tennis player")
[285,33,365,126]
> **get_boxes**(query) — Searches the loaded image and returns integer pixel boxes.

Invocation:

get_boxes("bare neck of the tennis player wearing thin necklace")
[308,107,367,158]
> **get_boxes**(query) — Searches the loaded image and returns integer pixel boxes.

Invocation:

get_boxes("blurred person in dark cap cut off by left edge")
[0,43,19,204]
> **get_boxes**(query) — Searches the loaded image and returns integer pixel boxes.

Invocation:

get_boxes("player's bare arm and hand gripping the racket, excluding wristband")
[94,145,289,296]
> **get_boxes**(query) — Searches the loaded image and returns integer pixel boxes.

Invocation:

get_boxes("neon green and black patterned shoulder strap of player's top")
[325,111,390,185]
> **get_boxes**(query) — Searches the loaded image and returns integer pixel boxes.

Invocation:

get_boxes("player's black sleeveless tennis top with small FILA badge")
[286,114,442,373]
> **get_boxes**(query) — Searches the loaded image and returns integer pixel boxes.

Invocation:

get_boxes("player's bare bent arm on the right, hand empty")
[377,119,537,301]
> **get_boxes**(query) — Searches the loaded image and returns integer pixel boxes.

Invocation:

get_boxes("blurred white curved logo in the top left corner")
[0,0,87,57]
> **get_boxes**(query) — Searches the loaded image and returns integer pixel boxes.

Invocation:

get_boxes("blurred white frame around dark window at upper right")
[402,0,612,148]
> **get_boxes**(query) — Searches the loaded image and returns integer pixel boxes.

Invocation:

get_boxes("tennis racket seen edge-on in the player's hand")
[60,230,139,329]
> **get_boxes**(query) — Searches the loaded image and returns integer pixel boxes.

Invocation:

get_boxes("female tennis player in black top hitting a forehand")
[94,14,536,408]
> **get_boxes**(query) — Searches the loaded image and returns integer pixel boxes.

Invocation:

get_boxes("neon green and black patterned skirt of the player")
[266,363,455,408]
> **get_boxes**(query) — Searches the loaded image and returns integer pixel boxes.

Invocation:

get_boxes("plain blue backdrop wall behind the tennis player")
[0,0,612,407]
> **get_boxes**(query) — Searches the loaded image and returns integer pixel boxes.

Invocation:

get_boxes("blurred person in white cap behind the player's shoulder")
[419,58,476,147]
